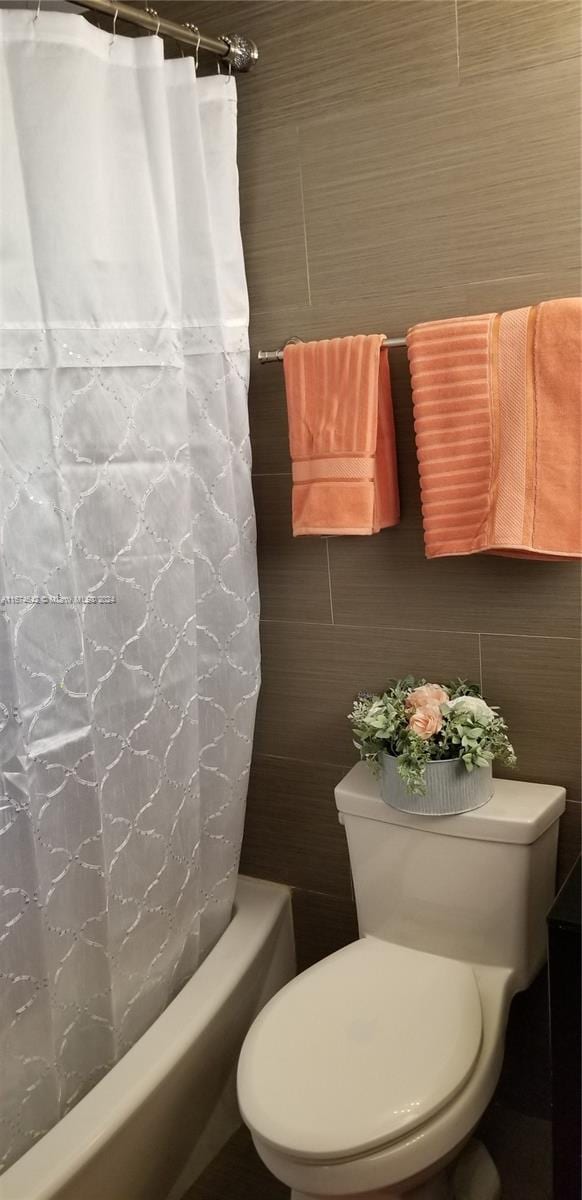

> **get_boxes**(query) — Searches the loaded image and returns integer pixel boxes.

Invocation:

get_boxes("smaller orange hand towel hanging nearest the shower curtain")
[283,334,400,536]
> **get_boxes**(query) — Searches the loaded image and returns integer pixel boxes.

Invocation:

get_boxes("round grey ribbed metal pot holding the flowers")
[380,754,493,817]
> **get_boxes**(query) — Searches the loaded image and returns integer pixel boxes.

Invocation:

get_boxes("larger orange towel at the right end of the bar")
[407,299,582,559]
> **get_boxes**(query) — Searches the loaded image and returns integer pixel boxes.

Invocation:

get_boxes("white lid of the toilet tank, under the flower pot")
[335,762,565,845]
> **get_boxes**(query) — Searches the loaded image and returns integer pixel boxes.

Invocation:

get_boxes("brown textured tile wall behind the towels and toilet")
[163,0,581,1106]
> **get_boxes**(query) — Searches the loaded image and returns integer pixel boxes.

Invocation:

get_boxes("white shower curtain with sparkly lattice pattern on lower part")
[0,7,258,1166]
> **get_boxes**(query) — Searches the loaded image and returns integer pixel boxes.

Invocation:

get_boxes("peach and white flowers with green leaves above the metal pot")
[348,676,516,796]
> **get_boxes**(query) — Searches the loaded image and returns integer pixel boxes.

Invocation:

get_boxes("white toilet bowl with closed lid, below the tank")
[239,937,511,1200]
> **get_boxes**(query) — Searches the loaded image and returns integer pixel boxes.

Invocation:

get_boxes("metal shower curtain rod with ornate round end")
[74,0,259,71]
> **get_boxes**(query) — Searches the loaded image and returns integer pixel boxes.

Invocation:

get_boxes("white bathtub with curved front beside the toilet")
[0,876,295,1200]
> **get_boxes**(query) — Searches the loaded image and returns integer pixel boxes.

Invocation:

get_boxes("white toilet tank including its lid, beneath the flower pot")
[335,762,565,990]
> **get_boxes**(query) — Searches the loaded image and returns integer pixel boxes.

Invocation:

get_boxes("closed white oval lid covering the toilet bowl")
[238,937,482,1160]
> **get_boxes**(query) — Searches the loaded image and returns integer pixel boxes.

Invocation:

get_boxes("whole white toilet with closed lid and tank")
[238,763,565,1200]
